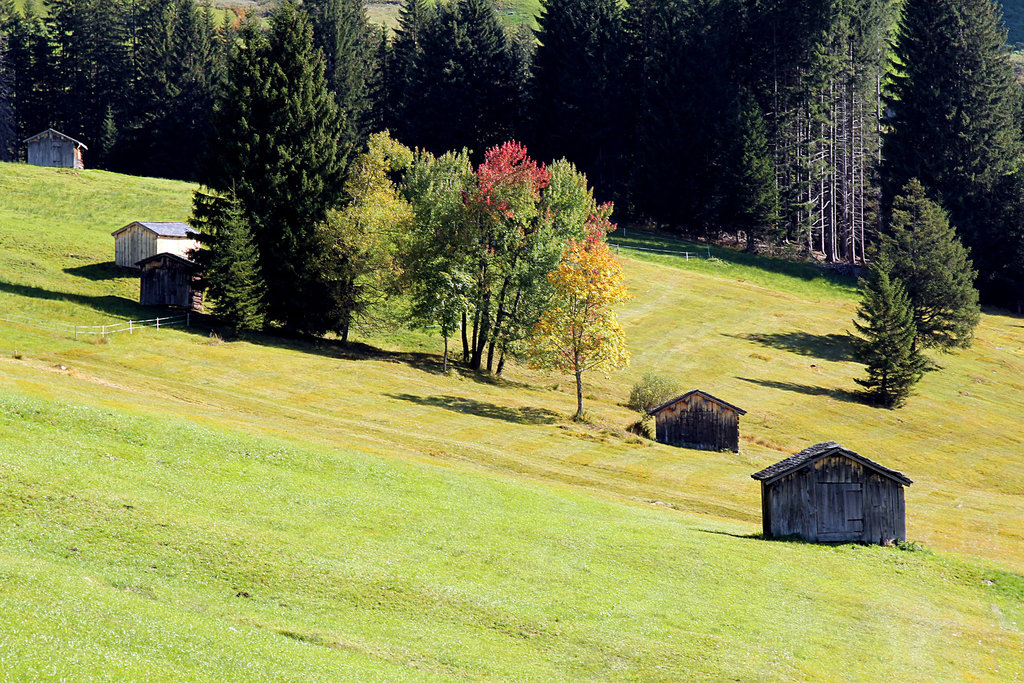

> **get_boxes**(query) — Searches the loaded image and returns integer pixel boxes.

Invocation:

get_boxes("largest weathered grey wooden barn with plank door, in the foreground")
[751,441,911,545]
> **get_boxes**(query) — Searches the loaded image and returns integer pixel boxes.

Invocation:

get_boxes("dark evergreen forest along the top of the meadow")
[0,0,1024,305]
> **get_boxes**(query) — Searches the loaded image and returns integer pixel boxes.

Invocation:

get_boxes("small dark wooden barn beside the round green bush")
[647,389,746,452]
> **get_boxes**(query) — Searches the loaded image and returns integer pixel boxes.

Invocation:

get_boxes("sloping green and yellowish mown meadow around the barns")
[0,165,1024,680]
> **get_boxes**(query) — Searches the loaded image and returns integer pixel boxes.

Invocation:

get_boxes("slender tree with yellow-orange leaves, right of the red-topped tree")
[527,224,630,420]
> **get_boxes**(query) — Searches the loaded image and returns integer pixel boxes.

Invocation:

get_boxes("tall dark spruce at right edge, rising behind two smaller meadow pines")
[883,0,1021,300]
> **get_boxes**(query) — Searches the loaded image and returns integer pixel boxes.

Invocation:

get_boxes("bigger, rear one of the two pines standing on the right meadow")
[882,179,981,351]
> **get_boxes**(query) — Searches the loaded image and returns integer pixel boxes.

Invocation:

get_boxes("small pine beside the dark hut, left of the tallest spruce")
[193,194,264,334]
